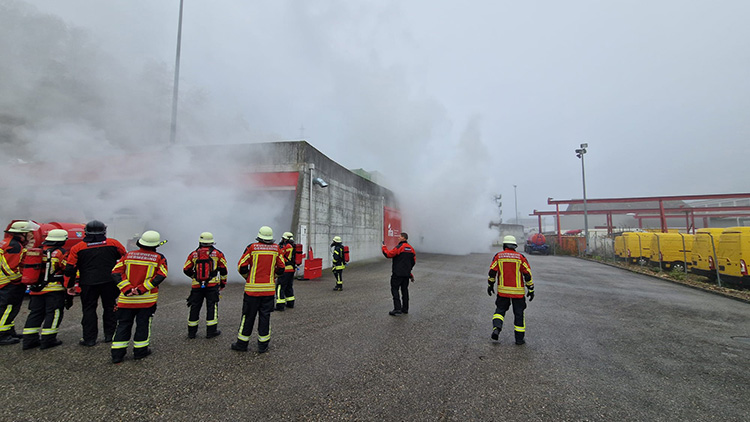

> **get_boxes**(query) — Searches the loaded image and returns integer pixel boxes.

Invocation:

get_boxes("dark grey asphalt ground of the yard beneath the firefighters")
[0,254,750,421]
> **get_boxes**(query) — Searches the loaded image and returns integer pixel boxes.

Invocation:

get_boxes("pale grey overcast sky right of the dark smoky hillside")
[5,0,750,237]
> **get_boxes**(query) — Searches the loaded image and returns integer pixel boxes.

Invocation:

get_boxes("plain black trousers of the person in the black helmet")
[81,283,120,341]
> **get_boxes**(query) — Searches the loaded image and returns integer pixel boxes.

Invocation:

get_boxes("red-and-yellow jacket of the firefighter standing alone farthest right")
[489,249,534,298]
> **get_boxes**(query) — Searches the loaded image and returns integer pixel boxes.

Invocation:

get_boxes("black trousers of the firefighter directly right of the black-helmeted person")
[112,305,156,358]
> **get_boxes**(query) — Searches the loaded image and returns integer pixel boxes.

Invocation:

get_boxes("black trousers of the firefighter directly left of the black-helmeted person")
[23,291,66,343]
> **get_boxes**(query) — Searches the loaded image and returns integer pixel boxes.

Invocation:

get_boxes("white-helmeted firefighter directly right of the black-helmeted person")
[111,230,167,363]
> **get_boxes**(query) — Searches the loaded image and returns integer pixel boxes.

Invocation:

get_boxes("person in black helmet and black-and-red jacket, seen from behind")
[65,220,127,347]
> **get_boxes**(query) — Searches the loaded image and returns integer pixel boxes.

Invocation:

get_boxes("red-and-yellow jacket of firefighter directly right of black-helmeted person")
[112,247,167,308]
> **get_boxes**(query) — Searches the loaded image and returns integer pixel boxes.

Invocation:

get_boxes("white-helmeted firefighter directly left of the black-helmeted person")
[22,229,68,350]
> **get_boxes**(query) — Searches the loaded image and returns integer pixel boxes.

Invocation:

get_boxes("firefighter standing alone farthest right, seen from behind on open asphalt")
[487,236,534,345]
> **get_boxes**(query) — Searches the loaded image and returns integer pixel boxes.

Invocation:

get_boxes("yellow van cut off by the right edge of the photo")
[716,227,750,286]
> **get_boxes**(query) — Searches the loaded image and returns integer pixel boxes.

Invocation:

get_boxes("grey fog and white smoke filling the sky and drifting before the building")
[0,0,750,258]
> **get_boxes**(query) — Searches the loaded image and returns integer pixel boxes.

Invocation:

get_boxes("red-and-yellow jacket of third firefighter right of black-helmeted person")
[237,242,285,296]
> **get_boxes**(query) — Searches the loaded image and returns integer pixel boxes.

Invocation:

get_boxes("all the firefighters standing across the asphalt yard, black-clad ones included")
[0,220,534,363]
